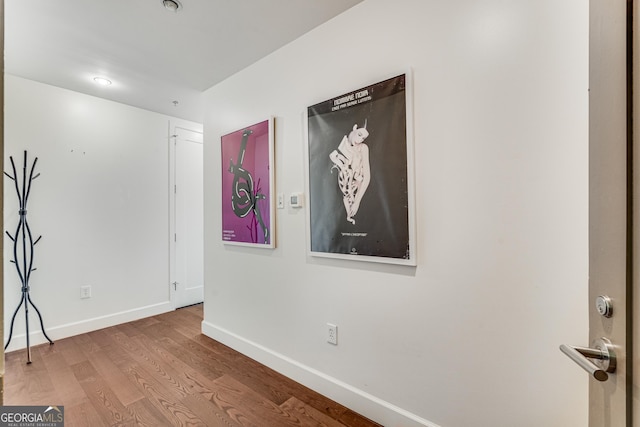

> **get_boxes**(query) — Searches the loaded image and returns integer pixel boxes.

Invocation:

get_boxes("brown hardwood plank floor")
[4,304,379,427]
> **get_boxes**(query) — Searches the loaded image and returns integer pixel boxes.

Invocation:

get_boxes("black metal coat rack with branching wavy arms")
[4,151,53,364]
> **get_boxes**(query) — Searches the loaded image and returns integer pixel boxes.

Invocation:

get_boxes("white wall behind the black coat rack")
[4,75,200,351]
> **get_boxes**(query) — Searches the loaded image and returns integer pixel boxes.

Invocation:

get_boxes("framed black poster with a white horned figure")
[306,74,416,265]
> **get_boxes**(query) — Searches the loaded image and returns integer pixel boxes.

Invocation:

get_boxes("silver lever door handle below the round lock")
[560,338,616,381]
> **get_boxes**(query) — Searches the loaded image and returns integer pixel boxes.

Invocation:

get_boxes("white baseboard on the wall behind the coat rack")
[5,301,173,352]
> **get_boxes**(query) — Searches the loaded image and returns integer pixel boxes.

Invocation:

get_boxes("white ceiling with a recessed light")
[5,0,362,122]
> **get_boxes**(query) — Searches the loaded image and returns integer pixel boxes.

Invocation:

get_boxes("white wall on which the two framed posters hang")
[203,0,588,427]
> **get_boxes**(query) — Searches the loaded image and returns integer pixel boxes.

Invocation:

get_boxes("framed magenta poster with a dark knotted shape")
[220,118,275,248]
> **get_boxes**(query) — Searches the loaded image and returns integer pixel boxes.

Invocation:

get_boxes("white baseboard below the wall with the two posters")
[202,321,439,427]
